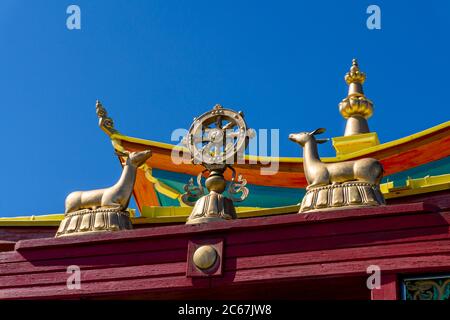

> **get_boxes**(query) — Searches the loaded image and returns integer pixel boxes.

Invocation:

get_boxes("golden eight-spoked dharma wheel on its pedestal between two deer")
[181,105,254,224]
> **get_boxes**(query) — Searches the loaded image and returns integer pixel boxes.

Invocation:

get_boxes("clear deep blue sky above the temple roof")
[0,0,450,216]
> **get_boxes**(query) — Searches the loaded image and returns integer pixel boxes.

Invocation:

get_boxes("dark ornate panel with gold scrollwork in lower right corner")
[403,277,450,300]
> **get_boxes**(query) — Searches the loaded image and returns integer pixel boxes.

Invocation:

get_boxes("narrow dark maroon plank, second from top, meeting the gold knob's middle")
[0,227,449,274]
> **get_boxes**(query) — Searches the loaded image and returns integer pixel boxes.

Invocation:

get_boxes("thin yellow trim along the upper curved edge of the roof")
[110,121,450,163]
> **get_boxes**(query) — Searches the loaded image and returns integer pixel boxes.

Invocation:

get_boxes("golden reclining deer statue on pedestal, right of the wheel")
[289,128,385,212]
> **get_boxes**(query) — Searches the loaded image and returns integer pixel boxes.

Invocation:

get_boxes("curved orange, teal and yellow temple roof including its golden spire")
[0,59,450,226]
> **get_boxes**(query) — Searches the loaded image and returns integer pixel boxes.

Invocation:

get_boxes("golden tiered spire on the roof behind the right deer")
[339,59,373,136]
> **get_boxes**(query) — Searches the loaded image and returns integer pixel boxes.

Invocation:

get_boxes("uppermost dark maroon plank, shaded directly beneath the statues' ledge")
[9,214,447,269]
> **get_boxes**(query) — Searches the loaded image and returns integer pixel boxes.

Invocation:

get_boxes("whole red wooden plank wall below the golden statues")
[0,193,450,299]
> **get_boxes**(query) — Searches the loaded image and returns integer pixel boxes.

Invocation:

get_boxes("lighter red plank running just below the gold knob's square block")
[0,250,450,298]
